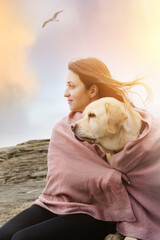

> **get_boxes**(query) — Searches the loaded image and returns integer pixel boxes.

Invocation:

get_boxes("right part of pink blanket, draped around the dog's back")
[111,110,160,240]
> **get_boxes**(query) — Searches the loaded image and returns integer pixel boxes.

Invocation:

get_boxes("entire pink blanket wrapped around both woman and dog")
[34,111,160,240]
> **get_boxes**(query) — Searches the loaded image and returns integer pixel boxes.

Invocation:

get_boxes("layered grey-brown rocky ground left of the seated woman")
[0,139,49,225]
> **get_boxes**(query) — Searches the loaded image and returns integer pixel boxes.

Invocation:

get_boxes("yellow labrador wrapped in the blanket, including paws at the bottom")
[71,97,143,240]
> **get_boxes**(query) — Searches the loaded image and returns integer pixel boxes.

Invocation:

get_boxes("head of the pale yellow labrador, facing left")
[71,97,128,143]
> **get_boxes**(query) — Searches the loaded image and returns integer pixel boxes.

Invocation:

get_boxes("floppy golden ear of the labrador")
[105,102,128,134]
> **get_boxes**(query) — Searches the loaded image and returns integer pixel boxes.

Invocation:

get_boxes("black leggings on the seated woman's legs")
[0,205,115,240]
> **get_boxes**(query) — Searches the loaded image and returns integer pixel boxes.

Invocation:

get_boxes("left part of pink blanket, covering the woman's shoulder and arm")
[34,113,135,222]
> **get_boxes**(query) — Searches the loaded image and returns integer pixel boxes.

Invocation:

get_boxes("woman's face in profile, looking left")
[64,70,91,112]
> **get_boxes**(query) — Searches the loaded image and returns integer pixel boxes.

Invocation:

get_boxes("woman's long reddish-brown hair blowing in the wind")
[68,57,151,105]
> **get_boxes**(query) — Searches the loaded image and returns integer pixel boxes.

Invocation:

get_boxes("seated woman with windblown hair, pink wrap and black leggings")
[0,58,151,240]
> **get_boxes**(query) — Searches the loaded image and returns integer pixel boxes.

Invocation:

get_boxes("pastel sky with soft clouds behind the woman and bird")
[0,0,160,148]
